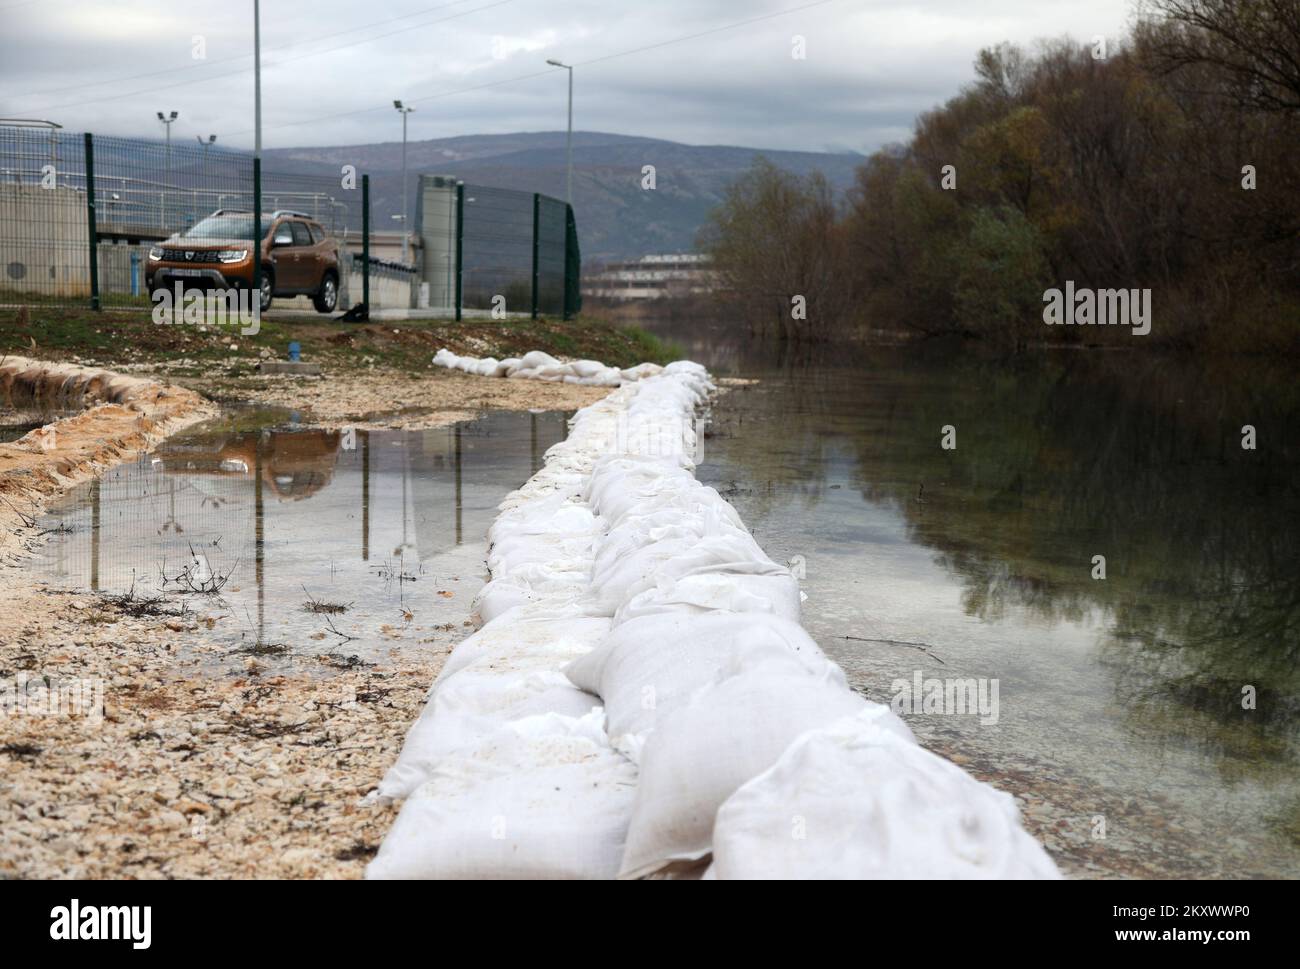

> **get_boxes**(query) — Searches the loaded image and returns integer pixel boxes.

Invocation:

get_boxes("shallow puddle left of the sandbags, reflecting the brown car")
[39,411,569,662]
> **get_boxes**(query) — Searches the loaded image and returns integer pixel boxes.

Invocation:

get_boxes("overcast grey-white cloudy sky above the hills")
[0,0,1132,151]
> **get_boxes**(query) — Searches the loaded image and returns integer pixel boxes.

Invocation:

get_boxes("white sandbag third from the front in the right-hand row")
[564,613,848,760]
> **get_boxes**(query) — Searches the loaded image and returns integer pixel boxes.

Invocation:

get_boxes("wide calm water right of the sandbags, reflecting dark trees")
[663,317,1300,877]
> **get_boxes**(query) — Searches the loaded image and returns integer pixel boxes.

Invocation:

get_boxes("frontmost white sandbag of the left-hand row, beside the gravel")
[365,711,636,879]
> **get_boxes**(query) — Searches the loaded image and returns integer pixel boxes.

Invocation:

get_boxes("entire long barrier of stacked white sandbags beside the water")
[367,354,1060,878]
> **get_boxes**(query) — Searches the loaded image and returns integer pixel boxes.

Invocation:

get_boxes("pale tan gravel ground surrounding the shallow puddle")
[0,362,501,878]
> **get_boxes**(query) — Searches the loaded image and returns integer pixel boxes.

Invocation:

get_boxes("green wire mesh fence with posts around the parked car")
[0,122,580,319]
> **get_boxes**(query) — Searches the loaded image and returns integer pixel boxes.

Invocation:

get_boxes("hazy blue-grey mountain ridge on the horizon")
[264,131,863,264]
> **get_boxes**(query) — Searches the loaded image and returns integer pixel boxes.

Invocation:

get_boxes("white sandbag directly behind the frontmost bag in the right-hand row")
[619,669,911,878]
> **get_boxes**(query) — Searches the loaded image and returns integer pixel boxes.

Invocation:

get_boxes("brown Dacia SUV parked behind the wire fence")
[146,208,341,313]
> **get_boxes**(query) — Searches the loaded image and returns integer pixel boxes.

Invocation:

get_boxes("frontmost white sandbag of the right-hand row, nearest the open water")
[710,715,1061,879]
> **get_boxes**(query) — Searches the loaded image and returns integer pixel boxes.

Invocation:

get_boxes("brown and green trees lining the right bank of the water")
[702,0,1300,351]
